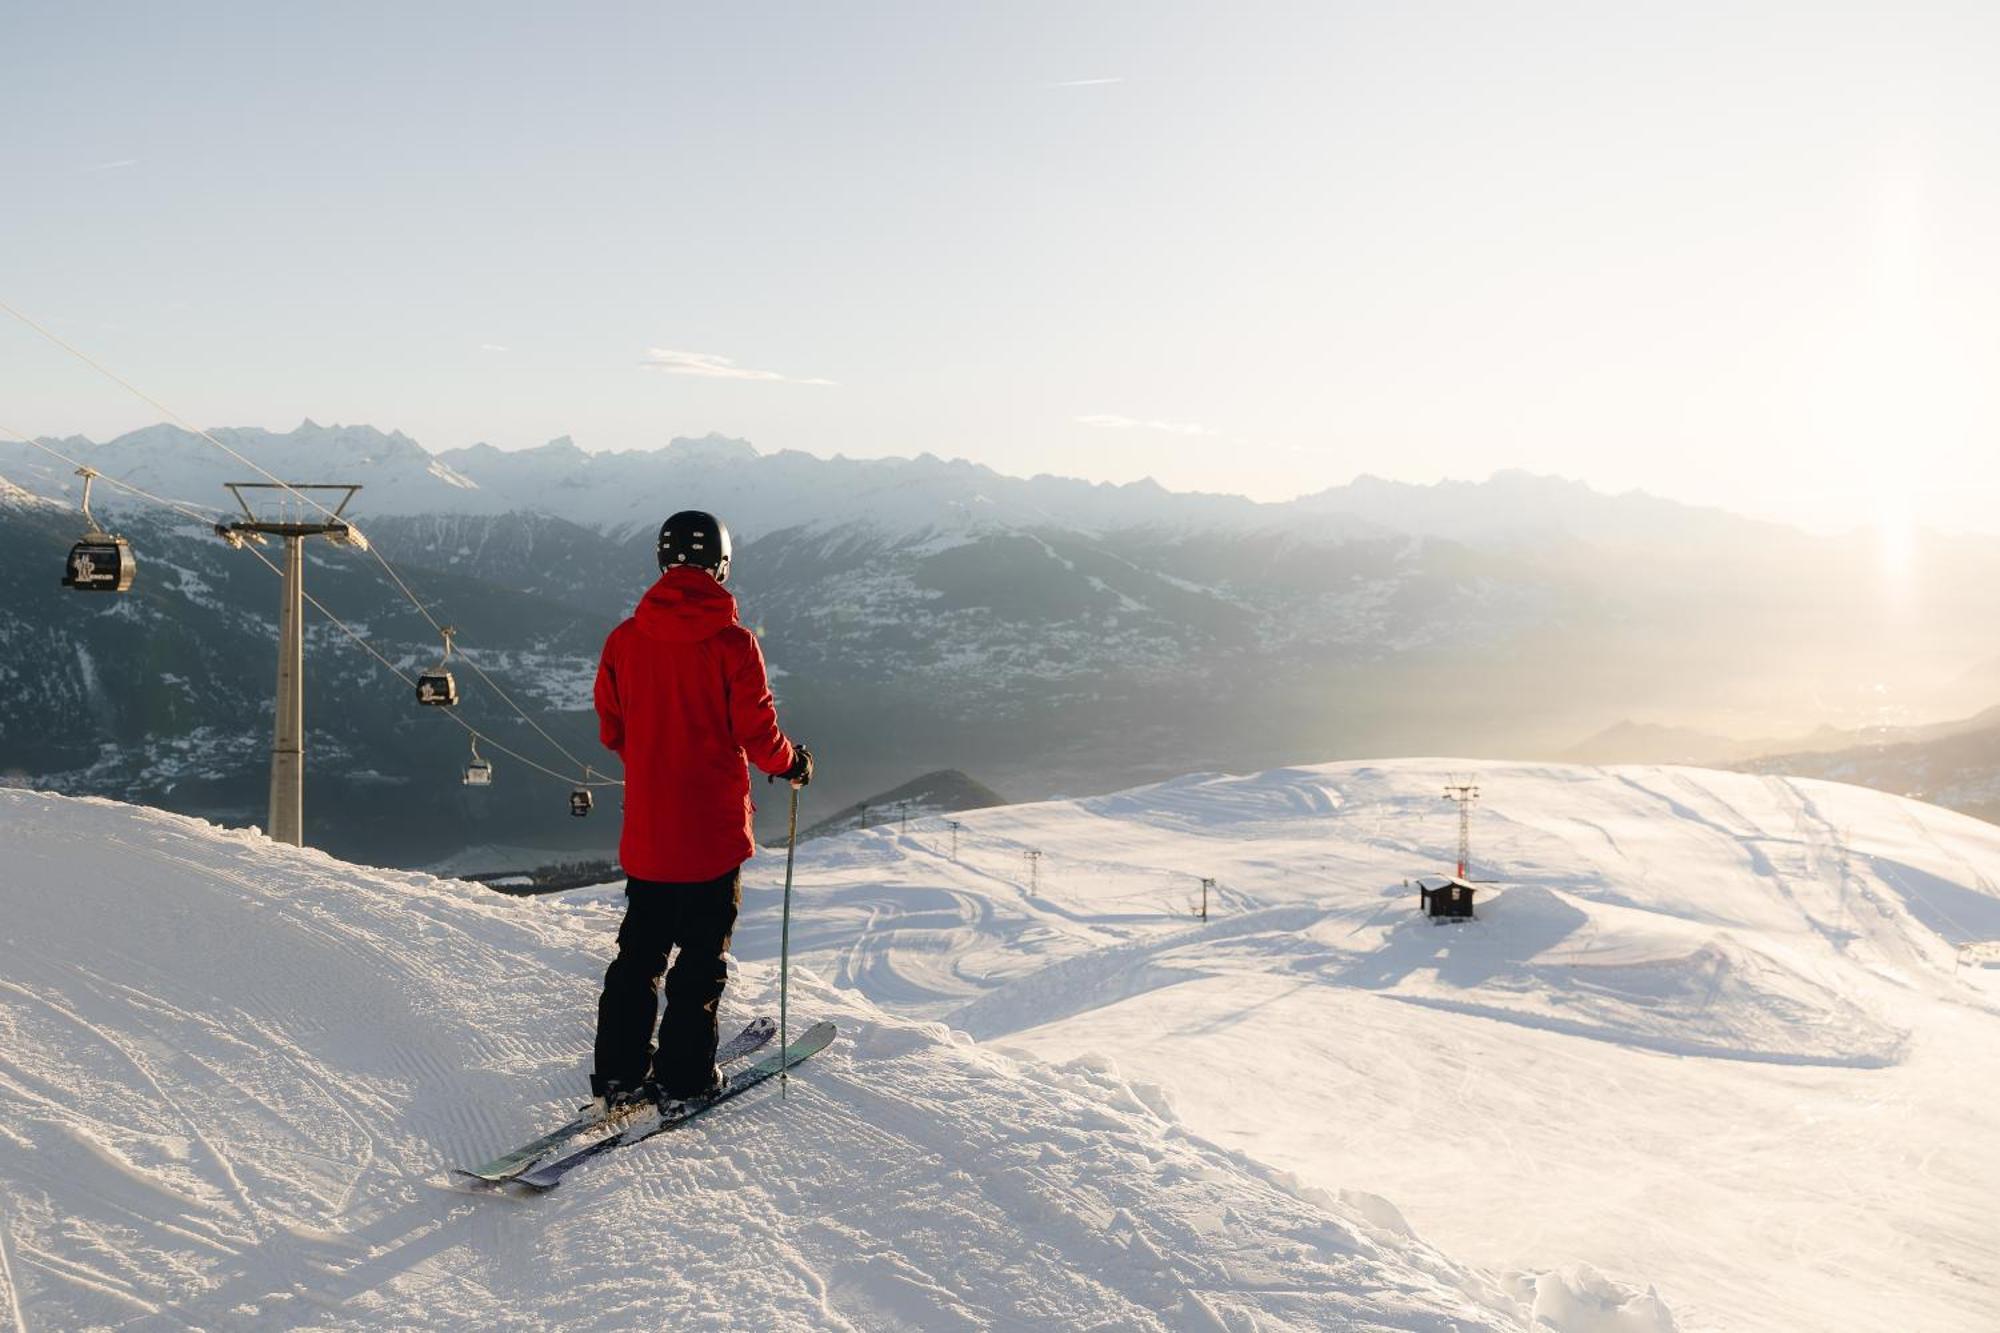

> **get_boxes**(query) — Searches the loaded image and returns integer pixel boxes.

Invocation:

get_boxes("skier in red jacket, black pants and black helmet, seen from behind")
[590,510,812,1107]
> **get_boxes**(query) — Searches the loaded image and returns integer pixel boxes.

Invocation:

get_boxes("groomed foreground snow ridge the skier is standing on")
[0,791,1670,1331]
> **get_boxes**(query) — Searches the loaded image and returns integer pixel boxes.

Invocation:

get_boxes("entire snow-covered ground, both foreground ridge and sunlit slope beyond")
[0,761,2000,1333]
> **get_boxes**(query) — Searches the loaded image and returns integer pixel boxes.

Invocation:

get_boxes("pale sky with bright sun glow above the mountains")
[0,0,2000,532]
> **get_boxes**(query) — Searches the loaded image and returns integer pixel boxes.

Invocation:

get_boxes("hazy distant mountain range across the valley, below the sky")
[0,422,2000,863]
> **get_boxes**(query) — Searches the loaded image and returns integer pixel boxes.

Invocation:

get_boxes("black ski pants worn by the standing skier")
[592,867,742,1097]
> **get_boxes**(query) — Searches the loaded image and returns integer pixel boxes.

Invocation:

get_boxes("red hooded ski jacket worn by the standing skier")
[596,568,792,883]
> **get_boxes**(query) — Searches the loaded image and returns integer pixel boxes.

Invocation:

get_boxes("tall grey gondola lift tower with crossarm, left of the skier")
[216,482,368,847]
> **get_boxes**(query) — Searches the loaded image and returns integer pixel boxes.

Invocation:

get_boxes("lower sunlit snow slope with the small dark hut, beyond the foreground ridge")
[652,761,2000,1331]
